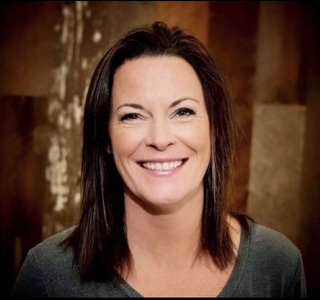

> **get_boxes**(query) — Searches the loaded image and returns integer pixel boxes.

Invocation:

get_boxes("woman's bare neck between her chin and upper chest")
[125,191,203,264]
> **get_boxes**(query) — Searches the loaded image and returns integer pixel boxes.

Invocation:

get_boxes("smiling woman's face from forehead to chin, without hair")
[109,56,210,207]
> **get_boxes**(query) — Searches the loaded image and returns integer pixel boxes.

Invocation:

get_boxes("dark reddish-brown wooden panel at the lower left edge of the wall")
[0,96,48,296]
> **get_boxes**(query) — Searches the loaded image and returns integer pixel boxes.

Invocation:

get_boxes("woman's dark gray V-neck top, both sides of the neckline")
[12,223,306,297]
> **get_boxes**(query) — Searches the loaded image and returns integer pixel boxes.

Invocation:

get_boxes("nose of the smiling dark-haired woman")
[145,121,174,151]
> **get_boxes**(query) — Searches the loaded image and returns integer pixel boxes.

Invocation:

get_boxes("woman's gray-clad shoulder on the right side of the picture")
[221,217,306,297]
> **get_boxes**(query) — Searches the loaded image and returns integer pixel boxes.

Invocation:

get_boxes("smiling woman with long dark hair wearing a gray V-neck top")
[12,22,306,297]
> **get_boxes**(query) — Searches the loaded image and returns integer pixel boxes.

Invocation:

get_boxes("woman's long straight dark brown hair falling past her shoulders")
[64,22,248,280]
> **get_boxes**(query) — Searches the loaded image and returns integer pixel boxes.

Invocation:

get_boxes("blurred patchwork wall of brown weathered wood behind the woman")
[0,1,320,297]
